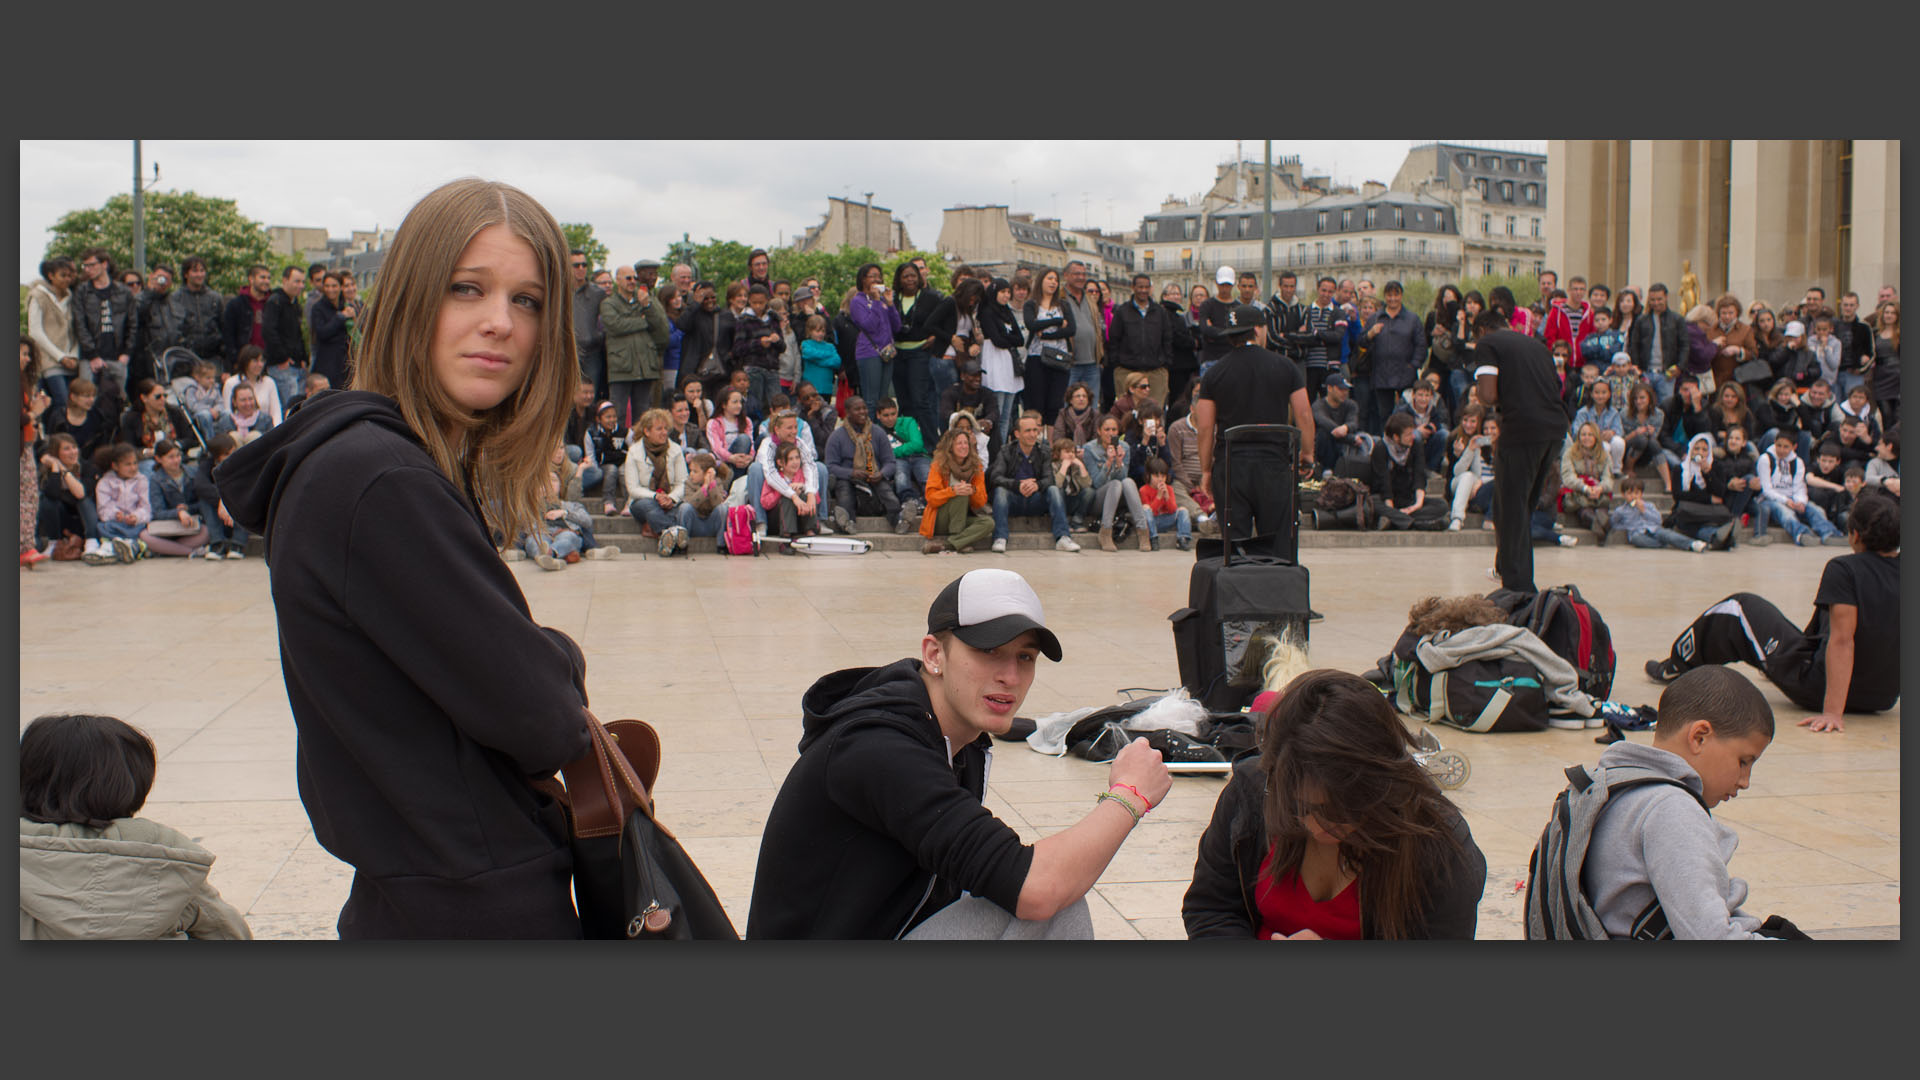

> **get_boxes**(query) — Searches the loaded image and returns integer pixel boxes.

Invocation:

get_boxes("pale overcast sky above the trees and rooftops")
[19,138,1546,281]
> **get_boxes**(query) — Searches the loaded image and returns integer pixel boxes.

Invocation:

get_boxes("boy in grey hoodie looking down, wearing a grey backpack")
[1580,667,1780,940]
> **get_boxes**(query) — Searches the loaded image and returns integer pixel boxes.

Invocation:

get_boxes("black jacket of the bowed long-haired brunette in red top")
[1181,757,1486,940]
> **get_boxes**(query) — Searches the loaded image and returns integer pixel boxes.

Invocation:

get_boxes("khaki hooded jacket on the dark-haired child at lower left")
[19,817,253,942]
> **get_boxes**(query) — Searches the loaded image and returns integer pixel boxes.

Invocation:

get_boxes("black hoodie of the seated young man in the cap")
[747,659,1033,938]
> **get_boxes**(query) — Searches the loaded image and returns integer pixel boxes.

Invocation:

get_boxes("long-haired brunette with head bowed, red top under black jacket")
[1181,669,1486,940]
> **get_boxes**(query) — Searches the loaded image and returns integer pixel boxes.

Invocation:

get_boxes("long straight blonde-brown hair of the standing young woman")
[348,177,580,536]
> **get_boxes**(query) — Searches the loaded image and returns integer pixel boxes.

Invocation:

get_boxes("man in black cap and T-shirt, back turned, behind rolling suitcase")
[1192,295,1315,540]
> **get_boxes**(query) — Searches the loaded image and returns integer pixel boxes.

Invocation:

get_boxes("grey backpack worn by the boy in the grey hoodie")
[1526,765,1707,942]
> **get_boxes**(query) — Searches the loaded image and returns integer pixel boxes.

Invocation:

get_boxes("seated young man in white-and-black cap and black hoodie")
[747,569,1173,940]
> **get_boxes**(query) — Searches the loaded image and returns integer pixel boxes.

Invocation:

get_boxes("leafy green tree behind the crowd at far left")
[46,192,274,294]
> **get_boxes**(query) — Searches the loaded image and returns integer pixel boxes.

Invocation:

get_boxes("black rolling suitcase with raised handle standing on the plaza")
[1167,425,1309,713]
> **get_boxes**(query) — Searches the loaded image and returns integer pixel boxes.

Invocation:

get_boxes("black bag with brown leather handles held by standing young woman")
[561,713,739,942]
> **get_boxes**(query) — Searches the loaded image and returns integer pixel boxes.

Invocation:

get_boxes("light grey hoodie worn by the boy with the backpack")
[1580,742,1768,942]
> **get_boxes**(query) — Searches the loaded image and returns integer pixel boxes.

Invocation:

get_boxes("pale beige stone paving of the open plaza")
[19,544,1901,938]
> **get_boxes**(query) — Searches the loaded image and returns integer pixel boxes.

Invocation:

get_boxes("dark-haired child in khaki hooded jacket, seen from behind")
[19,715,253,942]
